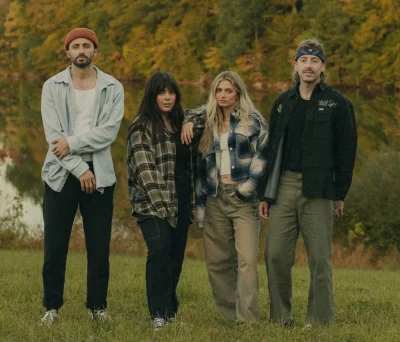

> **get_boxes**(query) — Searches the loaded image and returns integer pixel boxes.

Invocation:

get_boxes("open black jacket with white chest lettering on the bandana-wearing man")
[258,83,357,203]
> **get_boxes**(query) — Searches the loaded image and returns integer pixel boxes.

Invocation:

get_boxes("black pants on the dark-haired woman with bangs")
[138,175,190,319]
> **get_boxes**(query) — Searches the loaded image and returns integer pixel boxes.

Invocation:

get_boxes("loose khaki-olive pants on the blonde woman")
[203,184,260,323]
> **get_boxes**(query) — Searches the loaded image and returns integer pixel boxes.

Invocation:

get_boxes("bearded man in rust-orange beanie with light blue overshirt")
[41,28,124,325]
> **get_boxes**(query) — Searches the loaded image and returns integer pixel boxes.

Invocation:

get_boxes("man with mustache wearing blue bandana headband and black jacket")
[259,39,357,329]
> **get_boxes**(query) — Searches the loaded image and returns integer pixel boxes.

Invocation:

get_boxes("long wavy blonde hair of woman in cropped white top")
[199,71,258,154]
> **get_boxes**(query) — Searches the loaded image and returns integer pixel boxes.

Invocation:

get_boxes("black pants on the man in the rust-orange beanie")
[42,175,115,310]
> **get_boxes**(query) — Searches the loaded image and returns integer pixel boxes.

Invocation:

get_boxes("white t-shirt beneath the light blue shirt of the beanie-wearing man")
[73,84,97,161]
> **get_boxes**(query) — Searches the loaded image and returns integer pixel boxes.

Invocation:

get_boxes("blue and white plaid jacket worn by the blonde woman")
[185,105,268,227]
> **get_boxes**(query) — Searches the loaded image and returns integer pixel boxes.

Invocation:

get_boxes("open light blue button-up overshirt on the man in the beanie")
[41,66,124,193]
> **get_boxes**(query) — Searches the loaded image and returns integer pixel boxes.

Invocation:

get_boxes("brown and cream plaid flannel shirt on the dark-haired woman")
[127,123,194,227]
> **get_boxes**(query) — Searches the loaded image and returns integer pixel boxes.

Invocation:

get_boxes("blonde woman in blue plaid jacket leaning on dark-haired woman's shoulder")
[181,71,267,323]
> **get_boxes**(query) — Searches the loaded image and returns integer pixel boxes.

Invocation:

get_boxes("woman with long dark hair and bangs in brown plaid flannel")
[127,72,194,329]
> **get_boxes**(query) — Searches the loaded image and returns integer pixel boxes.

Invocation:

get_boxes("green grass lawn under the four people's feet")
[0,250,400,342]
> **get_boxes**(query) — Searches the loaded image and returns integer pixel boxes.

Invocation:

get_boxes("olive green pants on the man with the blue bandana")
[264,171,334,324]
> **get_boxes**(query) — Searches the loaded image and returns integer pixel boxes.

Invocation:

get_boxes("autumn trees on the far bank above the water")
[0,0,400,88]
